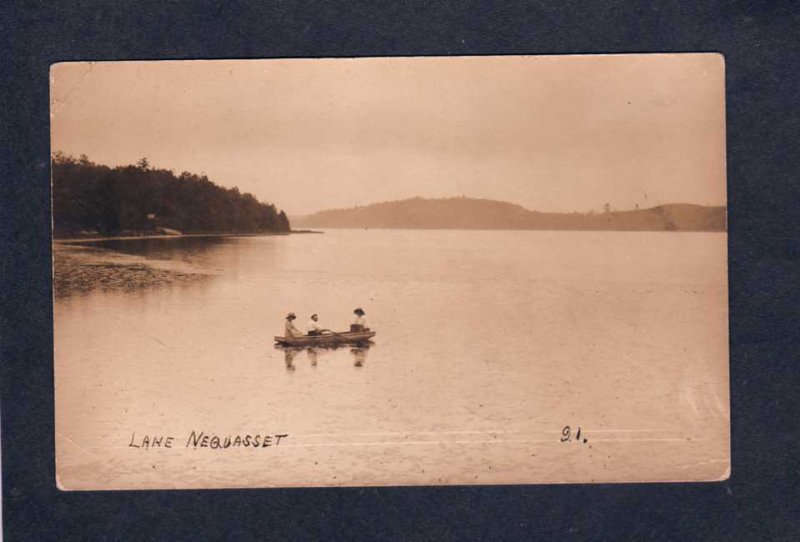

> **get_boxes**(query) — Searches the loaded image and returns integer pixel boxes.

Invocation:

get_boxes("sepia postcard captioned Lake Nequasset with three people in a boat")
[51,54,731,490]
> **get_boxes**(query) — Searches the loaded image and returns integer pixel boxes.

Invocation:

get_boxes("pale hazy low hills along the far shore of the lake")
[292,197,726,231]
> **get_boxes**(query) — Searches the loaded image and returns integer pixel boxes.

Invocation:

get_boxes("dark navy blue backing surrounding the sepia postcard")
[0,0,800,540]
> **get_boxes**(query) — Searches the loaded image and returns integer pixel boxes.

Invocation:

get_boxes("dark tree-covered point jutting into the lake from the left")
[52,153,290,237]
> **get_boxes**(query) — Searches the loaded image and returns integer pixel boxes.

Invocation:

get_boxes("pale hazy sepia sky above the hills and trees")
[51,54,725,215]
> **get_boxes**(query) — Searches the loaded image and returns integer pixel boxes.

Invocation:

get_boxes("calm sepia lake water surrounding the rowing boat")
[55,230,729,489]
